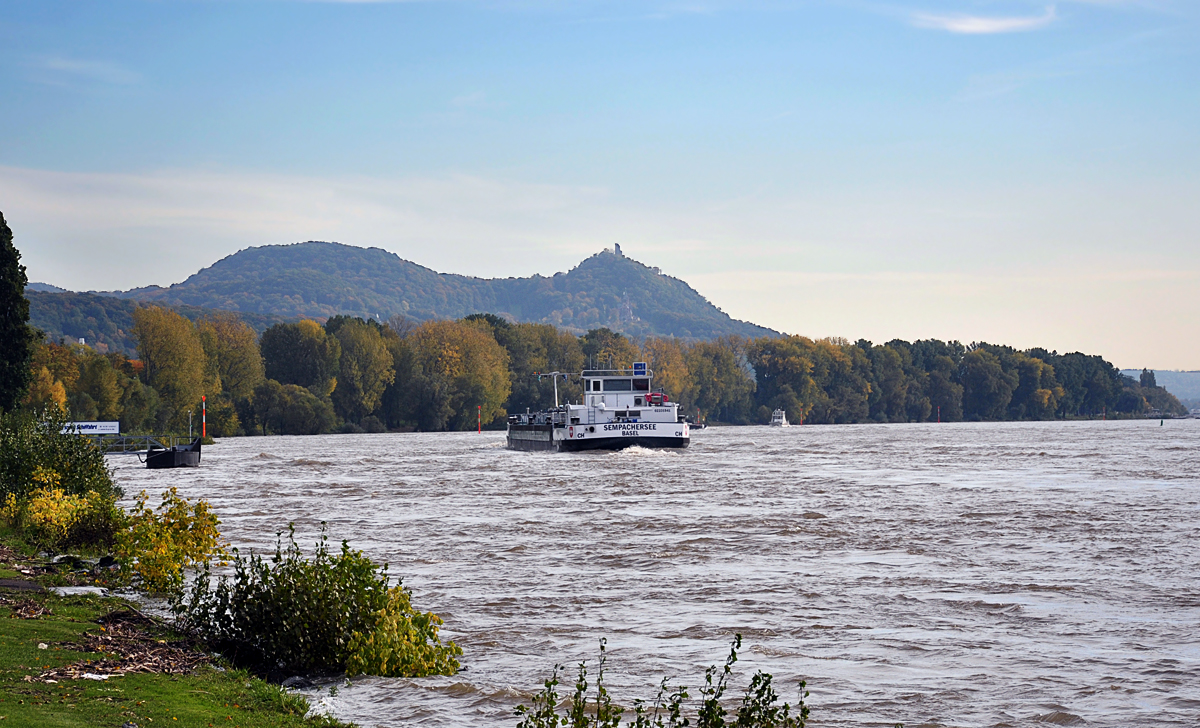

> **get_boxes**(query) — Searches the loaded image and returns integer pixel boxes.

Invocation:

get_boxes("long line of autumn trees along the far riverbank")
[11,307,1184,437]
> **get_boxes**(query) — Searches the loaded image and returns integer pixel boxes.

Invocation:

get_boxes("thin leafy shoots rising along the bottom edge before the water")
[516,634,809,728]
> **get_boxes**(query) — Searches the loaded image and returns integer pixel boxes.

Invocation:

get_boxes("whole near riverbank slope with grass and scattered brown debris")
[0,531,350,728]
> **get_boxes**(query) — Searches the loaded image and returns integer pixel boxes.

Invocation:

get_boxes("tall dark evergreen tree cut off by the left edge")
[0,213,37,411]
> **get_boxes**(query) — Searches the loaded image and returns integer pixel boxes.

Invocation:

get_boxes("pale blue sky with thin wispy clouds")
[0,0,1200,369]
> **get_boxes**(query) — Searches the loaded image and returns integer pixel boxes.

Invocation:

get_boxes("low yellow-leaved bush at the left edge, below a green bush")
[0,470,125,550]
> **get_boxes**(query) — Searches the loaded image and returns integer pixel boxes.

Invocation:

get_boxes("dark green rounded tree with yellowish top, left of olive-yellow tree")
[260,319,342,397]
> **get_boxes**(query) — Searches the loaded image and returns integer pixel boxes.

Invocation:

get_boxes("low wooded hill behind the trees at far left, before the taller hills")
[25,288,289,355]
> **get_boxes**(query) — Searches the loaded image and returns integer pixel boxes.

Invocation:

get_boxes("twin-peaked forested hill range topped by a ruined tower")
[105,242,775,339]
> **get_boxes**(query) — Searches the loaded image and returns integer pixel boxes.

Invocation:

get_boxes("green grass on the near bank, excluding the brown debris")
[0,540,347,728]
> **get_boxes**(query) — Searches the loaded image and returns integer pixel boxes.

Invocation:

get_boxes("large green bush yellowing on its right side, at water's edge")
[175,525,462,676]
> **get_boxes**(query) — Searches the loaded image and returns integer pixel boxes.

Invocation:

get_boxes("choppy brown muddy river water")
[112,420,1200,728]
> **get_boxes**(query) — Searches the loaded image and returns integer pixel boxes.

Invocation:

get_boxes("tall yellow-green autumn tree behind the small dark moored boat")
[133,306,216,431]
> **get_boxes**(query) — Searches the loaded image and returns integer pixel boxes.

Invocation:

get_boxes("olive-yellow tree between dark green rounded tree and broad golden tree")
[332,319,396,422]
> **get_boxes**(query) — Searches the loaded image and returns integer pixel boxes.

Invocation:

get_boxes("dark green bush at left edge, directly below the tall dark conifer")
[0,409,121,503]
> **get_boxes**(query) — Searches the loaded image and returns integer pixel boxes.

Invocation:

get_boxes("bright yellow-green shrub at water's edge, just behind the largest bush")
[116,488,227,595]
